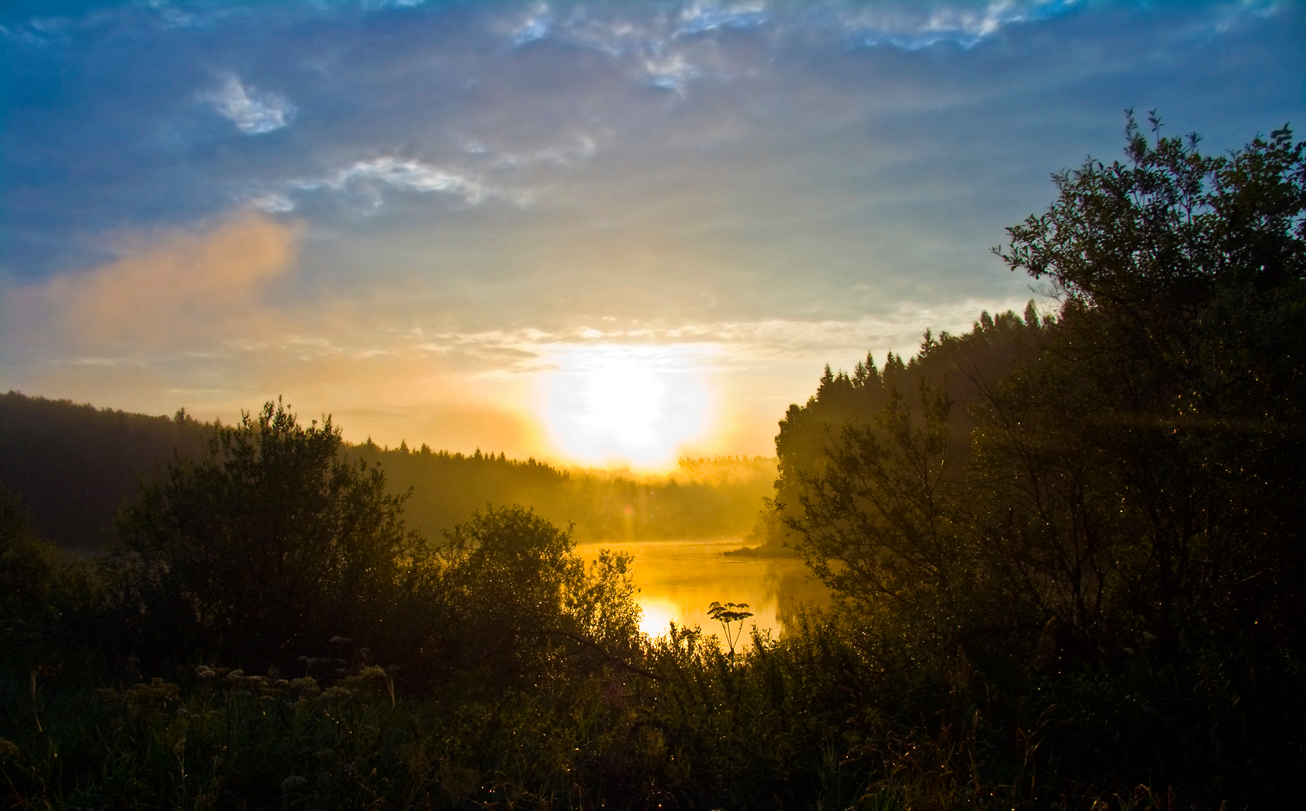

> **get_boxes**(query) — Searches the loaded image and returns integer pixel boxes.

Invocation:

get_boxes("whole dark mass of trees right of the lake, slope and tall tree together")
[777,116,1306,662]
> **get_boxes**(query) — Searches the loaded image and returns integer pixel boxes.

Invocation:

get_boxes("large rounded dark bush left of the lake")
[111,404,423,669]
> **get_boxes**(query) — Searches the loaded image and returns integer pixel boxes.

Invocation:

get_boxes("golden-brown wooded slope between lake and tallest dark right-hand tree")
[776,304,1055,666]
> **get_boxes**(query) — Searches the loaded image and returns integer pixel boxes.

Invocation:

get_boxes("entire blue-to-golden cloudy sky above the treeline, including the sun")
[0,0,1306,469]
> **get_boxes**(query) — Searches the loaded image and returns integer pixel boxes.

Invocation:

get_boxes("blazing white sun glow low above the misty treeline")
[542,345,712,469]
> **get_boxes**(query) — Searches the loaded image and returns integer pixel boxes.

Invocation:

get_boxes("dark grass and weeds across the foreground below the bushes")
[0,616,1303,810]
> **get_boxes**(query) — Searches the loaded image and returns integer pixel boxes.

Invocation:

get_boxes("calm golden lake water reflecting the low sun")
[576,538,829,636]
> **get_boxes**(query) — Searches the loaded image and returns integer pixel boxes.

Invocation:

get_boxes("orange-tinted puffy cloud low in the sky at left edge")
[5,214,299,354]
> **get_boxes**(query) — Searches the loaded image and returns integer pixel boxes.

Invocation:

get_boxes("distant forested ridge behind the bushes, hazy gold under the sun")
[0,392,776,551]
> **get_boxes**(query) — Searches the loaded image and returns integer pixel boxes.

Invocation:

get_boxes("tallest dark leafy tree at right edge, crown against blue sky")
[981,116,1306,656]
